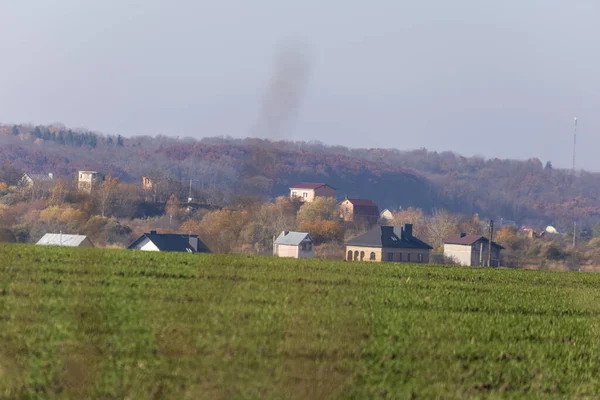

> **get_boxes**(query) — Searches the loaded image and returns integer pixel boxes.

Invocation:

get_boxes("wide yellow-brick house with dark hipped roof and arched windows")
[344,224,433,263]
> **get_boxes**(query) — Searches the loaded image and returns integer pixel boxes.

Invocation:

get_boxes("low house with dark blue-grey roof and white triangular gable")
[127,231,210,253]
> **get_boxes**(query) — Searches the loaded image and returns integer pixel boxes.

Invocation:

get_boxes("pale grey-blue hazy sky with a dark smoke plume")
[0,0,600,171]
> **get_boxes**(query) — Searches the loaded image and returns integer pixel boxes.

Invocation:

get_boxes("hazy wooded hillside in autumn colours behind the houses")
[0,125,600,231]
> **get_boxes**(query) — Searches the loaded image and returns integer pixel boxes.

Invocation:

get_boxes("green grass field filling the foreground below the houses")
[0,245,600,399]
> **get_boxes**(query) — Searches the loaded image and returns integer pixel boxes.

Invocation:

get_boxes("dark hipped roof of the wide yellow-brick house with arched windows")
[345,226,433,250]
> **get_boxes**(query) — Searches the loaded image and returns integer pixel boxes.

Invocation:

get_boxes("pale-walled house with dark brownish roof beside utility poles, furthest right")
[444,233,504,266]
